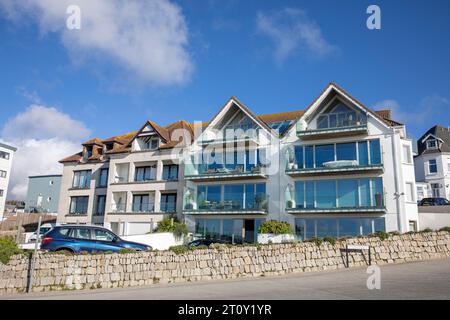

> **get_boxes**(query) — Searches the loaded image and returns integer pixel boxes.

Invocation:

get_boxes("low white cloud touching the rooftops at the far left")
[0,105,90,199]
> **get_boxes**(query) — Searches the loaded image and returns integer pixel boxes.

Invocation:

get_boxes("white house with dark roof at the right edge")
[414,126,450,199]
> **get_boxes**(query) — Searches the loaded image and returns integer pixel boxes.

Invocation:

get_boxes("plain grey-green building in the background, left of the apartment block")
[25,175,62,213]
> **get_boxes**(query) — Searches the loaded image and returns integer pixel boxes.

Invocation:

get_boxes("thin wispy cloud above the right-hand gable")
[256,8,337,64]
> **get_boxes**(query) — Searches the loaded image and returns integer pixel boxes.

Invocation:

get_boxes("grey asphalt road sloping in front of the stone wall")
[0,259,450,300]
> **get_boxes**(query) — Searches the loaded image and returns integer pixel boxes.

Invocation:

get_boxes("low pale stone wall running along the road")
[0,231,450,294]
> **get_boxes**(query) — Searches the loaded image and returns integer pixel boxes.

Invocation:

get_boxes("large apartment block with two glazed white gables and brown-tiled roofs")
[59,83,418,242]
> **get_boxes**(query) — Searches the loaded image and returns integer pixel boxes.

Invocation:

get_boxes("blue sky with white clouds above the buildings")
[0,0,450,199]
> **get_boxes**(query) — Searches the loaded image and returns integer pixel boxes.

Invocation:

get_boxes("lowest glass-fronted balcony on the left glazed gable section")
[183,194,268,214]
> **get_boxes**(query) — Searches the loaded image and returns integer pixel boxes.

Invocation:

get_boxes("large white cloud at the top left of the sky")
[0,0,193,85]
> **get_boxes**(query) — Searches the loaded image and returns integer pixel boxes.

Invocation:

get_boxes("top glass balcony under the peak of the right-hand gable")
[297,112,368,139]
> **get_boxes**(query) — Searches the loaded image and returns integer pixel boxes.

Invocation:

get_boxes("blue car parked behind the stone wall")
[41,225,152,253]
